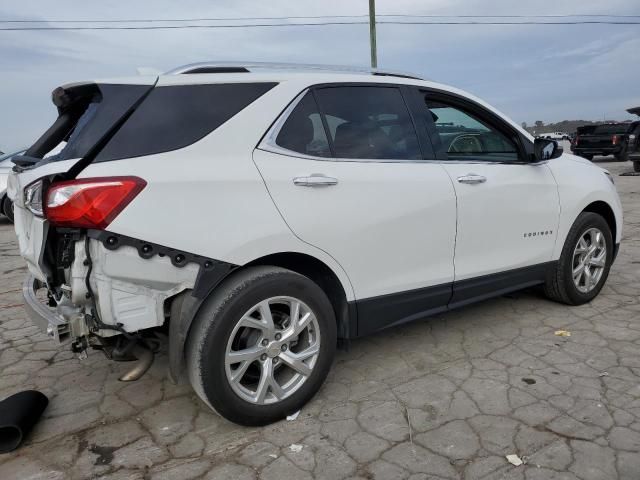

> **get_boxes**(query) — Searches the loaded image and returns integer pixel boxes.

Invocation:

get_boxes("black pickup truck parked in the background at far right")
[571,122,640,161]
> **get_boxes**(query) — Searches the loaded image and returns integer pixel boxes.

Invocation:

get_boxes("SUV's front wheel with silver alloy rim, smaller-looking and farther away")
[544,212,613,305]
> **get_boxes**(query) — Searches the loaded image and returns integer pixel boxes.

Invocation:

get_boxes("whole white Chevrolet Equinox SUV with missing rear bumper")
[9,64,622,425]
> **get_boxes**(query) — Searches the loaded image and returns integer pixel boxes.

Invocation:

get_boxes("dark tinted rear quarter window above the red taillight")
[95,83,276,162]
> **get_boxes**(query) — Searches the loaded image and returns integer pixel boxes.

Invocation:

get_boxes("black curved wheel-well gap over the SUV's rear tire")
[245,252,356,339]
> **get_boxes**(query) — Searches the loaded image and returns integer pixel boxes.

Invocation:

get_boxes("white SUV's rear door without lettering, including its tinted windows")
[254,84,456,335]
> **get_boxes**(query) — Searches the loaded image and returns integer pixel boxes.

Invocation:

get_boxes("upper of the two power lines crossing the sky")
[0,13,640,23]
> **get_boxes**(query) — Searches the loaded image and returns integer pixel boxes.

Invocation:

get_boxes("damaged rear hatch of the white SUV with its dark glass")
[7,77,157,283]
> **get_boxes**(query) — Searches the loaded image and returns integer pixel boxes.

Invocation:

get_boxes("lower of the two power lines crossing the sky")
[0,20,640,32]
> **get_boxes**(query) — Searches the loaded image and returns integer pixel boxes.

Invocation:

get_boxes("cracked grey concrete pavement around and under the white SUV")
[0,158,640,480]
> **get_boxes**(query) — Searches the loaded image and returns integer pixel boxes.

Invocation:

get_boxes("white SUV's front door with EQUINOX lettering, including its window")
[416,90,560,304]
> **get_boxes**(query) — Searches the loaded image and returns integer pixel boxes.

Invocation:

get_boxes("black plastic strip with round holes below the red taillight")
[87,230,238,299]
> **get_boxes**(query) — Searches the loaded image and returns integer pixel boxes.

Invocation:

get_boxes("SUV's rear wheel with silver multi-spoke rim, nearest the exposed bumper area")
[186,267,336,426]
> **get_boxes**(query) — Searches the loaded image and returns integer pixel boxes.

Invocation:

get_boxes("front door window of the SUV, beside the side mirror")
[426,99,518,161]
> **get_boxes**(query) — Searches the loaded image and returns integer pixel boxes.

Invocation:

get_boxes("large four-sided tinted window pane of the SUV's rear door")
[316,87,422,160]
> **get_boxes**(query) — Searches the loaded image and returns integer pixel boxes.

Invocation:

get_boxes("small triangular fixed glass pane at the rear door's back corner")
[276,92,331,157]
